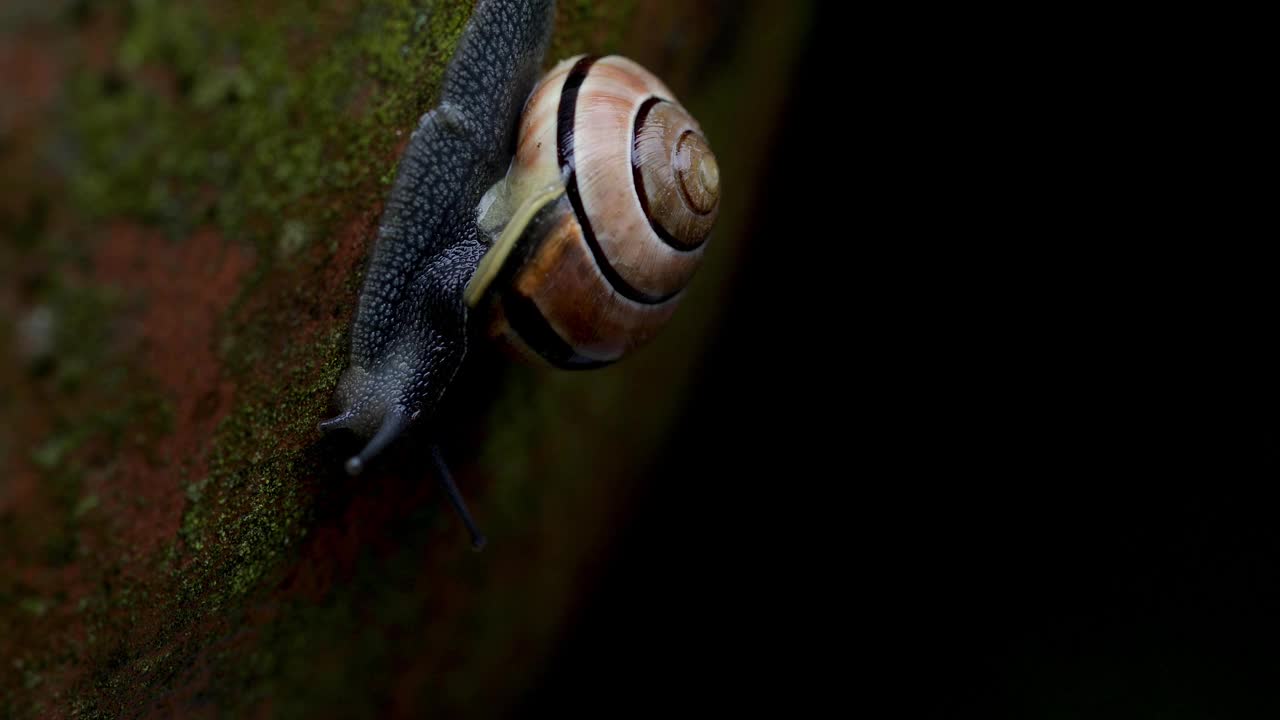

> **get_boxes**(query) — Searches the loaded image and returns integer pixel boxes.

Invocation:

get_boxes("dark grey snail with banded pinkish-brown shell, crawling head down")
[320,0,719,550]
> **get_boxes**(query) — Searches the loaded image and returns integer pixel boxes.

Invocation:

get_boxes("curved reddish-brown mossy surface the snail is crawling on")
[0,0,806,717]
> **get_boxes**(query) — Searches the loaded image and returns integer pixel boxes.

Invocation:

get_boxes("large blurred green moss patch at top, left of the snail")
[70,0,466,256]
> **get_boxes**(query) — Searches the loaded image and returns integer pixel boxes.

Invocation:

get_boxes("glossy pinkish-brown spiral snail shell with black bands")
[465,56,719,369]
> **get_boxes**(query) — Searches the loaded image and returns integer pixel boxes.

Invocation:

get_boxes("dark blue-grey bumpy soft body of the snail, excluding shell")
[320,0,554,453]
